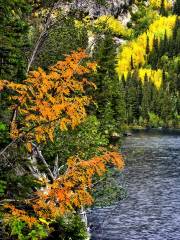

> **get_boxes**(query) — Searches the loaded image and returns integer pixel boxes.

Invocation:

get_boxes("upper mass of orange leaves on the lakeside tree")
[0,50,96,142]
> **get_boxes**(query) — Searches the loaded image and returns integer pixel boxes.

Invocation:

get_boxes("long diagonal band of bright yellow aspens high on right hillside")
[117,15,176,87]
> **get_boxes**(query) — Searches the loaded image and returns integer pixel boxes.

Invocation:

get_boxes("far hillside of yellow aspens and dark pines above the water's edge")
[117,13,180,127]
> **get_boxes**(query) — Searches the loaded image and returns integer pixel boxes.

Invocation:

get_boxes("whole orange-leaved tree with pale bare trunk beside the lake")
[0,50,123,239]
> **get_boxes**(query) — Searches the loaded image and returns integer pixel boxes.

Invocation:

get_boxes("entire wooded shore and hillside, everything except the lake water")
[0,0,180,240]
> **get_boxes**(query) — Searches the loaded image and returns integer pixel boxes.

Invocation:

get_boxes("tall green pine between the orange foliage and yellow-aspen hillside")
[94,34,125,131]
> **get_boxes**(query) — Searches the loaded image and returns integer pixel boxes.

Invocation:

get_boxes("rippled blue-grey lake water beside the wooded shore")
[89,132,180,240]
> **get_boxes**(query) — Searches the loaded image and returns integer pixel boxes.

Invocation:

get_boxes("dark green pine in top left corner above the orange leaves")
[0,0,30,80]
